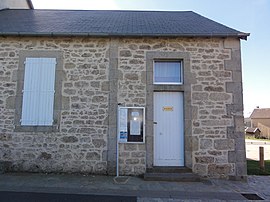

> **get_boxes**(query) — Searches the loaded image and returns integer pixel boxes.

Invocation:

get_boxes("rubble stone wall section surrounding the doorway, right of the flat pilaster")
[118,38,246,178]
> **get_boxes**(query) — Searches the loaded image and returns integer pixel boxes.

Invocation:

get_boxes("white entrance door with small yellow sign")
[154,92,184,166]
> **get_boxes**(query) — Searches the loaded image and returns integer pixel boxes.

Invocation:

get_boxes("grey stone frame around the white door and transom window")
[145,51,192,168]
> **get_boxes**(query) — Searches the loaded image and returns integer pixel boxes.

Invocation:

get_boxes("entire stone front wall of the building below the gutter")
[0,37,246,179]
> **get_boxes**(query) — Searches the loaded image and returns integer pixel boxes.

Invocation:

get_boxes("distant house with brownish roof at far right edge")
[250,108,270,139]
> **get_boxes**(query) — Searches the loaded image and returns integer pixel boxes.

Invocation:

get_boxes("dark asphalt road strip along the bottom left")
[0,191,137,202]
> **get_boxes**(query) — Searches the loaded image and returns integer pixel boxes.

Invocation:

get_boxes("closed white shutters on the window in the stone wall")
[21,58,56,126]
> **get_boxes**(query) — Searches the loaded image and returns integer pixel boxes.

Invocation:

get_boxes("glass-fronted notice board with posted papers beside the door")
[118,107,144,143]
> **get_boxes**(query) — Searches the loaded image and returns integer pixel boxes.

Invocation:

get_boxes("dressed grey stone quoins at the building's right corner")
[223,39,247,180]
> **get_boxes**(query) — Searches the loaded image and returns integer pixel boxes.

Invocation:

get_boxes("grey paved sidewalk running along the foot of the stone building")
[0,173,270,202]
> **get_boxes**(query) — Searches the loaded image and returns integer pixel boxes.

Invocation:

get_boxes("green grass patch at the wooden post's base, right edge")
[247,159,270,175]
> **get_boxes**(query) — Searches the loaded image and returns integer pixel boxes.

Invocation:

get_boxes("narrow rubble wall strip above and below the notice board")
[118,40,148,175]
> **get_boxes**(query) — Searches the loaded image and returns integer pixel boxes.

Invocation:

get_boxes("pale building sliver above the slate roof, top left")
[0,0,34,10]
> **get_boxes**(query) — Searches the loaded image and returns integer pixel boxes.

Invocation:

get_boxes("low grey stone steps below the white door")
[144,173,200,182]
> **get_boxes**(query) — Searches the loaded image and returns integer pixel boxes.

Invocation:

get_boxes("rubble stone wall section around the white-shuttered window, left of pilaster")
[0,37,109,173]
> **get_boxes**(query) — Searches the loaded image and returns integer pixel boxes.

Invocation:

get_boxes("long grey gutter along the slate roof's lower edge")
[0,32,250,40]
